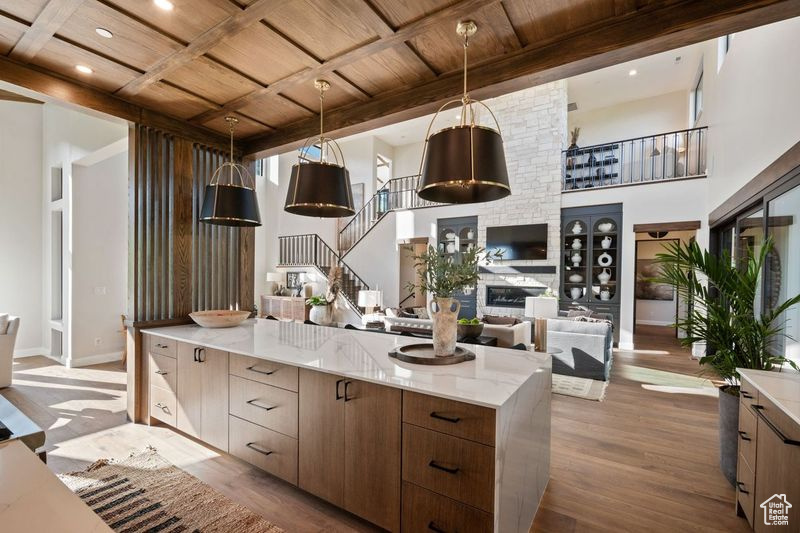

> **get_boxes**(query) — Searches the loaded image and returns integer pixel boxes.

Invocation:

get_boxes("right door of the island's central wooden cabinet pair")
[344,380,402,531]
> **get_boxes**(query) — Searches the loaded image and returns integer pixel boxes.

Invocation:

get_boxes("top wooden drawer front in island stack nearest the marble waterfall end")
[403,391,495,446]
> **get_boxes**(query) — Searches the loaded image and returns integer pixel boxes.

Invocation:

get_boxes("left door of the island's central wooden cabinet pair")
[297,369,344,507]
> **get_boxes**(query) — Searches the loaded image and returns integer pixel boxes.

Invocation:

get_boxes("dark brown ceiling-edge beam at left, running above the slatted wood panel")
[0,56,230,150]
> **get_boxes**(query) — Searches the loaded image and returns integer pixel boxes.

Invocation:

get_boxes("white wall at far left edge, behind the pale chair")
[0,101,43,355]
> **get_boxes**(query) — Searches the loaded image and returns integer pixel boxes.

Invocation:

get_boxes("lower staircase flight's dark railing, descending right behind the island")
[278,233,369,315]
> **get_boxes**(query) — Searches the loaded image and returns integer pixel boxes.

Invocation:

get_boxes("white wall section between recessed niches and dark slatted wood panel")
[69,149,128,366]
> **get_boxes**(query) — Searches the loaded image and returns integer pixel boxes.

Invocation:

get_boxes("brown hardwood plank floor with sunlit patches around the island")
[0,326,749,533]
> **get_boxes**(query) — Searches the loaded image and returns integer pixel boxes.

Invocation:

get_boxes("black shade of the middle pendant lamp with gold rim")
[284,161,356,218]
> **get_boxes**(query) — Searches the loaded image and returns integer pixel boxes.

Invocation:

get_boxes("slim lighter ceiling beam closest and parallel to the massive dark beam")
[186,0,499,124]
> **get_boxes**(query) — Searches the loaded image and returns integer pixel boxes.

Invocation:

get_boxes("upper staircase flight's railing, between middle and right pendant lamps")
[338,175,443,257]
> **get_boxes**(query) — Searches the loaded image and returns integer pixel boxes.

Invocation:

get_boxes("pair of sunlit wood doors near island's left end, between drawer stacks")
[177,342,228,451]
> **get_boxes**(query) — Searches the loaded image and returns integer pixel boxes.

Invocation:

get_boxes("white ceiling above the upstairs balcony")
[567,43,703,111]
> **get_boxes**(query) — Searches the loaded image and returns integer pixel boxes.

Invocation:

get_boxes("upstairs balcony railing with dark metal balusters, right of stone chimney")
[561,128,708,191]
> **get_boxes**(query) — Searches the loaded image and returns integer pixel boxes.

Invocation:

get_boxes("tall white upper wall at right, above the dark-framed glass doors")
[699,18,800,211]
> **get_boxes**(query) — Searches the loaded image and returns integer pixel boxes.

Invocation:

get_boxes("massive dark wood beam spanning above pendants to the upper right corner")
[241,0,800,156]
